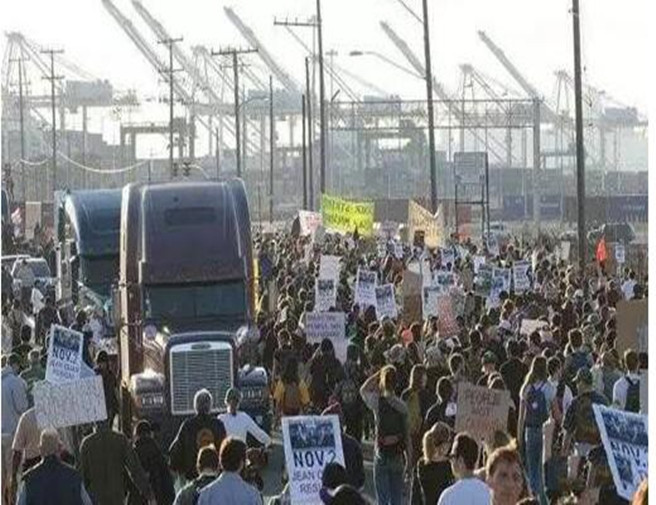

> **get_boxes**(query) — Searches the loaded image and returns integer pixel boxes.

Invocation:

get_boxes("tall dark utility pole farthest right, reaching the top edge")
[572,0,587,276]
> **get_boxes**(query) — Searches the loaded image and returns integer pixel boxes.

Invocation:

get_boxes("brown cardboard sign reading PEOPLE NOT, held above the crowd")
[455,382,510,441]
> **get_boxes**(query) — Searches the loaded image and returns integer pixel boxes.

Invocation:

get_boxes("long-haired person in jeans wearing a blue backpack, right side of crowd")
[517,356,556,505]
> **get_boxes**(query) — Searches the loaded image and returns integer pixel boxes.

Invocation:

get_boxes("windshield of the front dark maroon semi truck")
[144,280,246,320]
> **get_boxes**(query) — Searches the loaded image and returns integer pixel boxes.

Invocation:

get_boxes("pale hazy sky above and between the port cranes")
[0,0,650,114]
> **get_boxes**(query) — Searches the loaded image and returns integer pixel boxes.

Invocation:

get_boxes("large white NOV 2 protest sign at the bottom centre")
[282,415,345,505]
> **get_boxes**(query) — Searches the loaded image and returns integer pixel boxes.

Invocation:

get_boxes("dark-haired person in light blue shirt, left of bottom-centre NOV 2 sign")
[198,437,262,505]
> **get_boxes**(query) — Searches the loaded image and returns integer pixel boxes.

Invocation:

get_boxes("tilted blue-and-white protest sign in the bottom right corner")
[592,404,649,500]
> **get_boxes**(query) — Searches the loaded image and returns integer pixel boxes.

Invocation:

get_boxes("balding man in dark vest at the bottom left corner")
[18,429,93,505]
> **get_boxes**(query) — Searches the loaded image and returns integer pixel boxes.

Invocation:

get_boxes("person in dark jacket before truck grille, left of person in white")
[169,389,226,481]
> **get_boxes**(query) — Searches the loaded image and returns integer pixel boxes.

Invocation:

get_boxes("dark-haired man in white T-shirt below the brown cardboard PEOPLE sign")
[437,433,490,505]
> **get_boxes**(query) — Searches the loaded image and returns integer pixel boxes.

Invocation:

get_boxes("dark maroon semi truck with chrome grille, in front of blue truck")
[114,179,271,439]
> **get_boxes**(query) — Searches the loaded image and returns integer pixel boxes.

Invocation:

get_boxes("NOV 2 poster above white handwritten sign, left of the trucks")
[46,324,84,384]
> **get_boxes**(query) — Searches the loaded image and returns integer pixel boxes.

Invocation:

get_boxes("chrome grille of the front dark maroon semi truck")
[170,342,234,415]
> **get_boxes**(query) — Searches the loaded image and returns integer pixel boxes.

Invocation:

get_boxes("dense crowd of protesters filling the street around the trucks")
[2,219,648,505]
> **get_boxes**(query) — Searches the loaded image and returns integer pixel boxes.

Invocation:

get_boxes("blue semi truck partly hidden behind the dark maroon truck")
[55,189,121,307]
